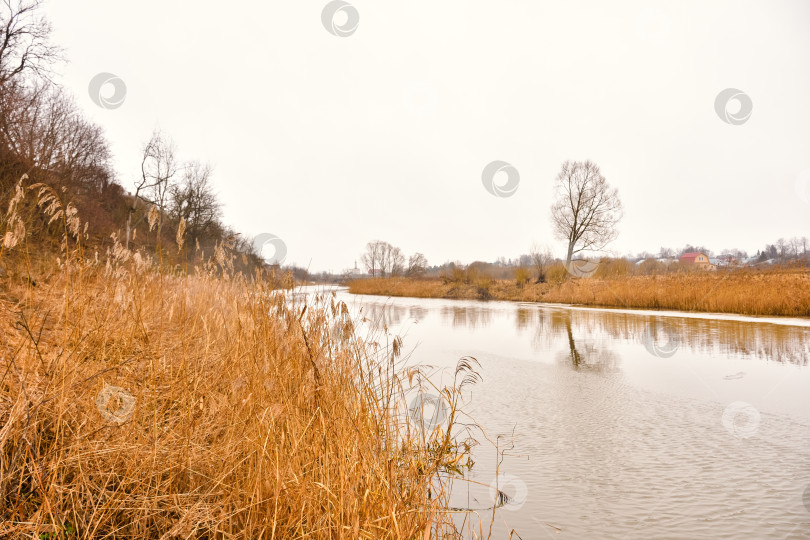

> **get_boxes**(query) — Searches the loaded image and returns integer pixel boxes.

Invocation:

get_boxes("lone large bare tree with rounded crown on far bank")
[551,161,622,266]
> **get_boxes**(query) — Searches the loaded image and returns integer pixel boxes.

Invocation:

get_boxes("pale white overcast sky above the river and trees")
[45,0,810,271]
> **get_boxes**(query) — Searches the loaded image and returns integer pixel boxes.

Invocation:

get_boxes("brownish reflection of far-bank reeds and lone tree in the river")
[363,302,810,370]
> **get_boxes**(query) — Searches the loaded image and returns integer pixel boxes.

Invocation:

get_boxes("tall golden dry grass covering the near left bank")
[0,176,475,539]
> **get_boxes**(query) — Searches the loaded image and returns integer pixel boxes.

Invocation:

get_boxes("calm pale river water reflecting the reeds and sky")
[324,291,810,540]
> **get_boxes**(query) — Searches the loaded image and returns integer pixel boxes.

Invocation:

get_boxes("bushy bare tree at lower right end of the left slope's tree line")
[169,161,222,243]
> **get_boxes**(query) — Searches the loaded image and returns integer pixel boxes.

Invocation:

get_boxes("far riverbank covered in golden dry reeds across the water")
[349,269,810,317]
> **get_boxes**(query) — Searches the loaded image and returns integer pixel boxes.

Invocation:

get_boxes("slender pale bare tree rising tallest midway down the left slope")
[126,131,180,247]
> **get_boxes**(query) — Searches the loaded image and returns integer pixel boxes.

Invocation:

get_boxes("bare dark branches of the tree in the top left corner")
[0,0,62,87]
